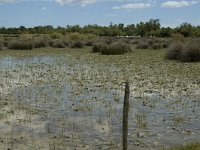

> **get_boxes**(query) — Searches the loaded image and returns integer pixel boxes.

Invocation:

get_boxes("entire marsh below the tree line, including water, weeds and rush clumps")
[0,20,200,150]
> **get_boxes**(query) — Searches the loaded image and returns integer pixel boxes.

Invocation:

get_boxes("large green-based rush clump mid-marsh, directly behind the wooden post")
[101,42,132,55]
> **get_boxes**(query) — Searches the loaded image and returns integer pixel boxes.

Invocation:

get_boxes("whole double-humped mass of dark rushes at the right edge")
[165,41,200,62]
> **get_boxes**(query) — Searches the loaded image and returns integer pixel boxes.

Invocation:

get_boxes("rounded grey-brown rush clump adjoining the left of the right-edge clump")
[165,42,183,60]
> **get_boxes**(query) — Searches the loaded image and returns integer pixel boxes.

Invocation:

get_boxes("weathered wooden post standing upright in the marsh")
[123,82,130,150]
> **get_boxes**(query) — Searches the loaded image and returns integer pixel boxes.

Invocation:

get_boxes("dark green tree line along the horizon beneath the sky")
[0,19,200,37]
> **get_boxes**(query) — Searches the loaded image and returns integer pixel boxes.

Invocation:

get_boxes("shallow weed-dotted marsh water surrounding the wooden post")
[0,49,200,150]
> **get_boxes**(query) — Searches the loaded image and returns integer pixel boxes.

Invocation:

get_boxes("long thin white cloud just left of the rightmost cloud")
[113,3,154,10]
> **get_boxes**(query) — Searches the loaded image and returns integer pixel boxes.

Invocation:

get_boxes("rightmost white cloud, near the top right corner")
[161,1,198,8]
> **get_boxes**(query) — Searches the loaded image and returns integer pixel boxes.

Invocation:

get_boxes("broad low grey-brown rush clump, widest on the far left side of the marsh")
[8,40,34,50]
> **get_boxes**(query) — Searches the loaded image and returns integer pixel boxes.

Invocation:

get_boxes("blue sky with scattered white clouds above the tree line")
[0,0,200,27]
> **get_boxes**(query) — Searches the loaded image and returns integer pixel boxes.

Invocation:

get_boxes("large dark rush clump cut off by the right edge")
[180,41,200,62]
